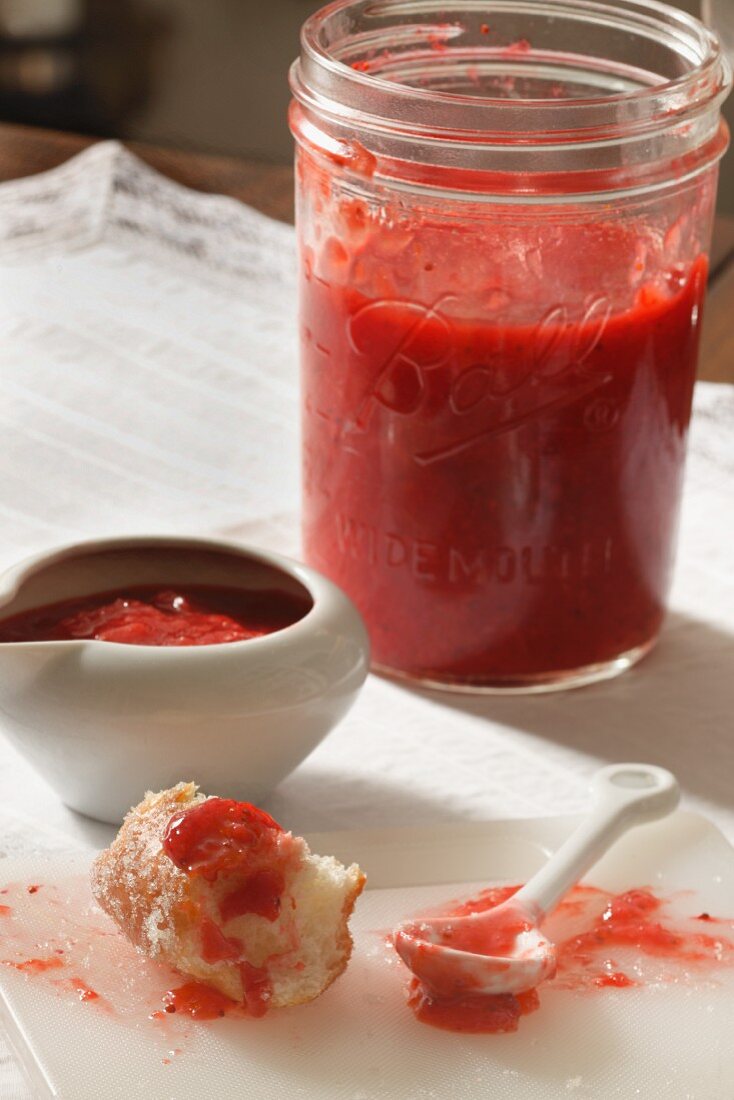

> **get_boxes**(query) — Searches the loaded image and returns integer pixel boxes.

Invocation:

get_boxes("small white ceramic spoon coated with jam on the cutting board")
[394,763,679,998]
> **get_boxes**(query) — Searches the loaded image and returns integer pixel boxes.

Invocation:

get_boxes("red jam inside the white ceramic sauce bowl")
[0,584,310,646]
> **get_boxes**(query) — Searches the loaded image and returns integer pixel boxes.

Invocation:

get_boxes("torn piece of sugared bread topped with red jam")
[91,783,364,1015]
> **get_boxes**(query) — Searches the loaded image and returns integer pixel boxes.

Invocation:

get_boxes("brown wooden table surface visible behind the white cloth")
[0,123,734,383]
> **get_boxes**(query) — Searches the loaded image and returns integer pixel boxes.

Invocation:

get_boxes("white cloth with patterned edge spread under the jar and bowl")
[0,142,734,1100]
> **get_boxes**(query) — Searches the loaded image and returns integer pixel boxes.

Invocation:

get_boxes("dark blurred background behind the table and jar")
[0,0,734,212]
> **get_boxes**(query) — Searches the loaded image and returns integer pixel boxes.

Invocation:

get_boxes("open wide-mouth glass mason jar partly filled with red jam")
[291,0,731,691]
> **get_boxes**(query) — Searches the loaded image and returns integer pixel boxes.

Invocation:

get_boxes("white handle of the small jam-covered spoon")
[515,763,680,920]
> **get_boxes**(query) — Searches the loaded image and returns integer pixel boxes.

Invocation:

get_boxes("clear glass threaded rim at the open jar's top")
[291,0,732,146]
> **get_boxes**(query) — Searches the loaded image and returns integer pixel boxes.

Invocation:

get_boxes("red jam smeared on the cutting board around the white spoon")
[408,886,734,1033]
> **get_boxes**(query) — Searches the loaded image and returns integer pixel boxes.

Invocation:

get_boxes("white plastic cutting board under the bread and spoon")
[0,813,734,1100]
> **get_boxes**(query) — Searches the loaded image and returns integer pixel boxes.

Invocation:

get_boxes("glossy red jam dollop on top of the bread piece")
[163,799,283,881]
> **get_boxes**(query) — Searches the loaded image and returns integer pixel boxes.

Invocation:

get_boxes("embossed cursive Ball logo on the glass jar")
[342,295,621,465]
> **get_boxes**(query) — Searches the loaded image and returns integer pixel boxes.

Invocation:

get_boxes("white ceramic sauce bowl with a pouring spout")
[0,537,369,824]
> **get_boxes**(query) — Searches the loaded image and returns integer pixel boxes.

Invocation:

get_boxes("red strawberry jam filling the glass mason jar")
[302,256,706,685]
